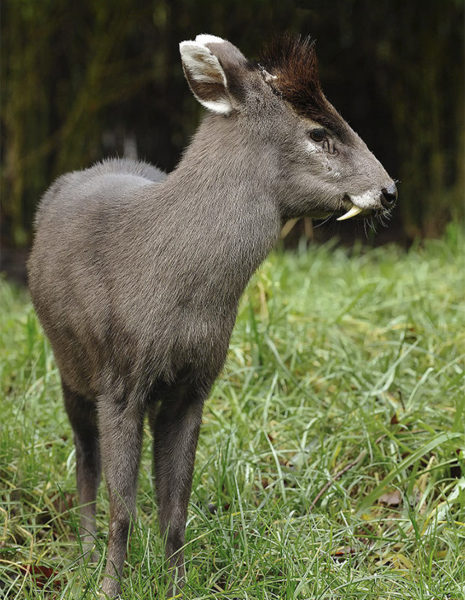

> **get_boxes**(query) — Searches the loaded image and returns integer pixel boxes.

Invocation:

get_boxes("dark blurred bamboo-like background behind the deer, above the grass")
[0,0,465,280]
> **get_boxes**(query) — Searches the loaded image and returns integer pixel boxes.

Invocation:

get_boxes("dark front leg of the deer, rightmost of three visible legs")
[149,385,208,585]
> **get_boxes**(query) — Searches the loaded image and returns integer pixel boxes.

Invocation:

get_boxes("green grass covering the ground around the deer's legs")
[0,223,465,600]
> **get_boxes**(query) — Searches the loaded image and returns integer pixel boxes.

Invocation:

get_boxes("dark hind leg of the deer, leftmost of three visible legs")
[62,382,101,560]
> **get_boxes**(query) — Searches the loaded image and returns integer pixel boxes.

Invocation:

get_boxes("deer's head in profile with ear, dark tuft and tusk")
[180,35,397,225]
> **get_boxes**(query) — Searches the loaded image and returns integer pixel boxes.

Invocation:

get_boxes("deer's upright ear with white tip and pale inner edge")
[179,35,233,115]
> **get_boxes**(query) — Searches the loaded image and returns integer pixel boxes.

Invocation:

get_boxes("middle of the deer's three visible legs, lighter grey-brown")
[98,394,144,598]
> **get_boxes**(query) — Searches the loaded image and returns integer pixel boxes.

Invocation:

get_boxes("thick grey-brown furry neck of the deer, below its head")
[164,116,281,292]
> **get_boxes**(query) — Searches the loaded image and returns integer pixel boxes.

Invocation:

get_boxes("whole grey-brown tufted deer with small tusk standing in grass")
[28,35,397,596]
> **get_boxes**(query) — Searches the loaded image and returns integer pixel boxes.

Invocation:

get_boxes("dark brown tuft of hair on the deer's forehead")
[259,34,344,137]
